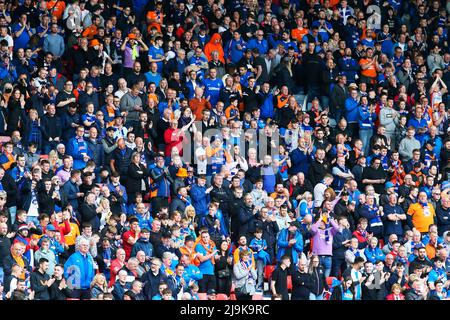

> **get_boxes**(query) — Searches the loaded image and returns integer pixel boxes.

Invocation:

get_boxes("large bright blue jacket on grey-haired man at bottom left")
[64,252,95,289]
